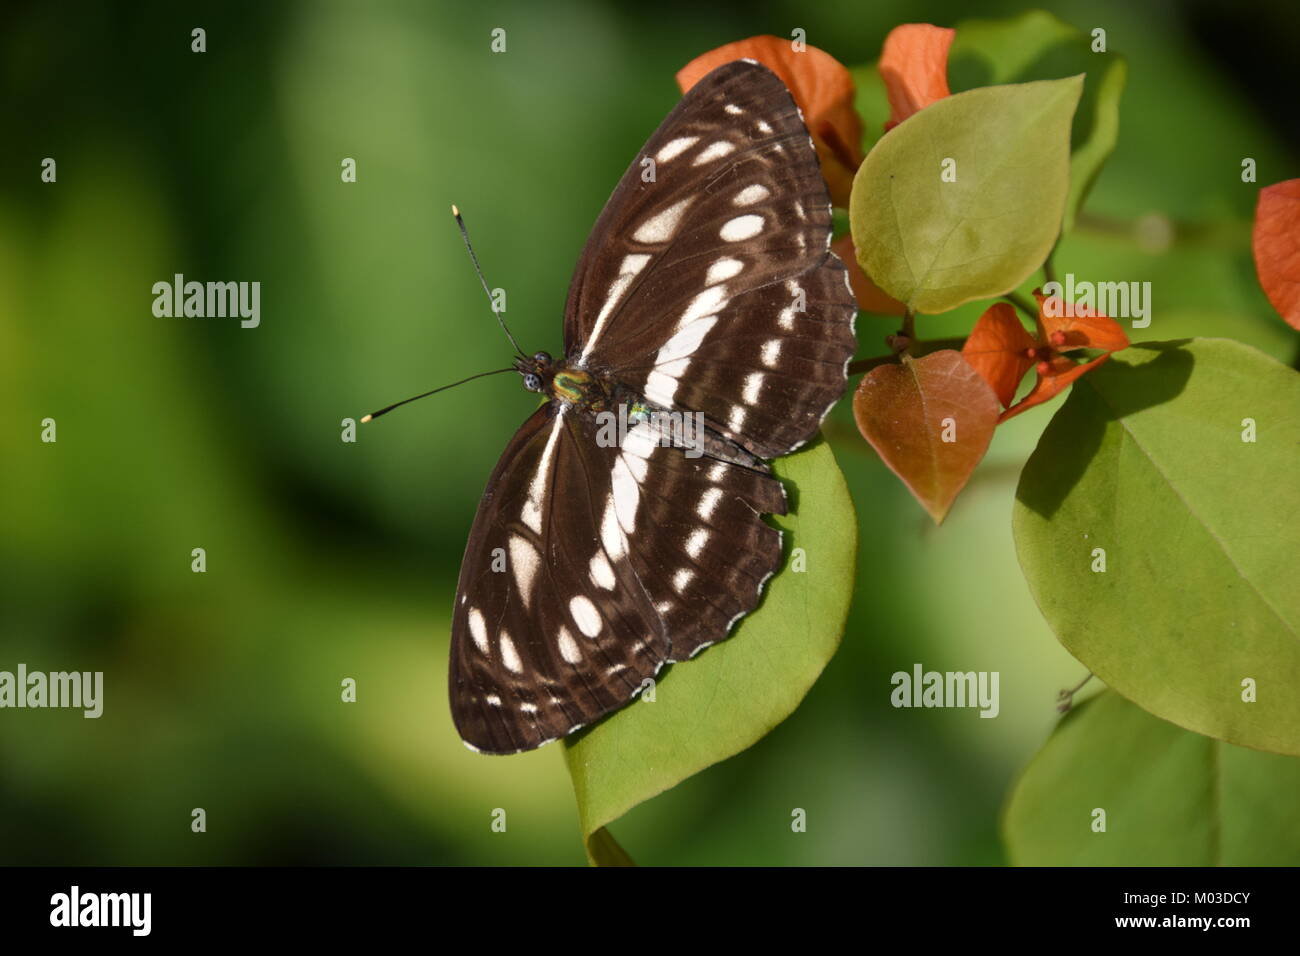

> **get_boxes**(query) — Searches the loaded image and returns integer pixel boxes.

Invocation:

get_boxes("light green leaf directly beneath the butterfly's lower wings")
[564,440,858,864]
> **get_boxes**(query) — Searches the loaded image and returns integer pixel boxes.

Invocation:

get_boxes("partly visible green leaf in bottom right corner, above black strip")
[1002,692,1300,866]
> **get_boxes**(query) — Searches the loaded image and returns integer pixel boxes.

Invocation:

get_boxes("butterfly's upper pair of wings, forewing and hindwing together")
[566,61,857,458]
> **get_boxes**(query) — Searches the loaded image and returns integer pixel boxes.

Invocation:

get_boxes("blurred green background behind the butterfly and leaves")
[0,1,1300,864]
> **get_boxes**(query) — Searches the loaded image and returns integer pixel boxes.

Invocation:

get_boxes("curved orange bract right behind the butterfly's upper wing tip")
[677,36,862,207]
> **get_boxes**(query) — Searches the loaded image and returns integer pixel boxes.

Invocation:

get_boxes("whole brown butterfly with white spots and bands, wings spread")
[449,60,857,753]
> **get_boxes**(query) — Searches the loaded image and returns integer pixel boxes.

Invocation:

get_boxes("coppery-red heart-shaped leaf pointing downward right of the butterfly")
[853,350,997,524]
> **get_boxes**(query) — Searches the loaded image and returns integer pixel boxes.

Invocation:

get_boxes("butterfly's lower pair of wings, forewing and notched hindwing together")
[450,405,785,753]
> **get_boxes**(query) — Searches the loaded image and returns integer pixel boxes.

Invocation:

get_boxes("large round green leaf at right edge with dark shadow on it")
[1013,338,1300,754]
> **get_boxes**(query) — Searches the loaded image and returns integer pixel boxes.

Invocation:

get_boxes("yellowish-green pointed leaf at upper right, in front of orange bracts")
[849,77,1083,312]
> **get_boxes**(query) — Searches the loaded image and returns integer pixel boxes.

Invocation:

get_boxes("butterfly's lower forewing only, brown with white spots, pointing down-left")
[450,405,668,753]
